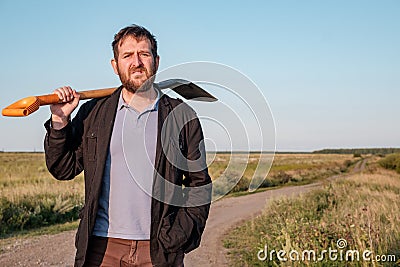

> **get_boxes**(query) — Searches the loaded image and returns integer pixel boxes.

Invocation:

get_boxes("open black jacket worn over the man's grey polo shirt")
[44,88,211,266]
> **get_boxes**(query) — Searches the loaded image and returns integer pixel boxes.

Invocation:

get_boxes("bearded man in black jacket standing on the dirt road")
[44,25,211,266]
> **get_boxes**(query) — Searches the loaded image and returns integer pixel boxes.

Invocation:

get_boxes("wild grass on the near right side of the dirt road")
[224,164,400,266]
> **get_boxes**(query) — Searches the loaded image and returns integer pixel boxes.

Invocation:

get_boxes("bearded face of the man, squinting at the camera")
[111,36,159,93]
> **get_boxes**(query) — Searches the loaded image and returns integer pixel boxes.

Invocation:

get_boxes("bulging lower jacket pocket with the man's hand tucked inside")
[158,209,194,252]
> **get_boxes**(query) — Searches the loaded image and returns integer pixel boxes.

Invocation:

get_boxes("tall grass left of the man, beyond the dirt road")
[0,153,83,237]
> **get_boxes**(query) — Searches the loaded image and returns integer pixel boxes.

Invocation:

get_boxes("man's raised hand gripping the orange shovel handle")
[50,86,79,130]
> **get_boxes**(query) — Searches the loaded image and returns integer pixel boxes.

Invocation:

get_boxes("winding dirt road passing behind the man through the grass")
[0,160,366,267]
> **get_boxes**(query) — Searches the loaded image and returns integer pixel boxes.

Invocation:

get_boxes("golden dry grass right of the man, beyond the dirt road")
[209,154,360,196]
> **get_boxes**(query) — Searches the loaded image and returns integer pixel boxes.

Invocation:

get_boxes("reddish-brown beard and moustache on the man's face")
[117,64,156,93]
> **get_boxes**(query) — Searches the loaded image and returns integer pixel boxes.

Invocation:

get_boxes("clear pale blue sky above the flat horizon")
[0,0,400,151]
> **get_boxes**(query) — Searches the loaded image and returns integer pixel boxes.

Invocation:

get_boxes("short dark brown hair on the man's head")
[111,24,157,60]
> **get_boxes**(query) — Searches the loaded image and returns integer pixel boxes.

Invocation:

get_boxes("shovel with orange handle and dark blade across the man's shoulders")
[2,79,218,117]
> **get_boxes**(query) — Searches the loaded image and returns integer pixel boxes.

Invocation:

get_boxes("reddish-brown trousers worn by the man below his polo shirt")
[84,236,184,267]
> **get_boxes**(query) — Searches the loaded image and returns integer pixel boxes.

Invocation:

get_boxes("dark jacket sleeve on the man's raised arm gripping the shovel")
[44,102,92,180]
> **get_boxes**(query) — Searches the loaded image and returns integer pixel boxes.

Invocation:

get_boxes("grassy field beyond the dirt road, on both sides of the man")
[0,153,359,238]
